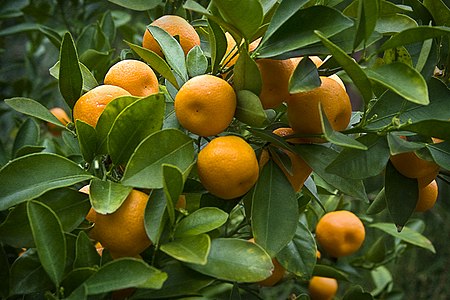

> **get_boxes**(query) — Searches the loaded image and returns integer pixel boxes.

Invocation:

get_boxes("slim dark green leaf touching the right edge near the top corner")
[378,26,450,53]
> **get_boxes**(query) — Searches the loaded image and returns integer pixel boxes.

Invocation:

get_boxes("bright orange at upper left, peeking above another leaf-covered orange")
[104,59,159,97]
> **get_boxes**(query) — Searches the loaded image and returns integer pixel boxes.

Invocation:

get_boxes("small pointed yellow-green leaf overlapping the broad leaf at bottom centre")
[160,234,211,265]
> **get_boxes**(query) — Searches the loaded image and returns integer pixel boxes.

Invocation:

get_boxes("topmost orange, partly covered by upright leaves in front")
[142,15,200,57]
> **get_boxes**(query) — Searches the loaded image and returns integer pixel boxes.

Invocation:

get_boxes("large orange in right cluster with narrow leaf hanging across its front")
[287,77,352,138]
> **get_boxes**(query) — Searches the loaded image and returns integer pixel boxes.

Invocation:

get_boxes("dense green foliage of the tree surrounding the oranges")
[0,0,450,299]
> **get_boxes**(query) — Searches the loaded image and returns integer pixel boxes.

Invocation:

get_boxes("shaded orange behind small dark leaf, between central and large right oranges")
[256,59,295,109]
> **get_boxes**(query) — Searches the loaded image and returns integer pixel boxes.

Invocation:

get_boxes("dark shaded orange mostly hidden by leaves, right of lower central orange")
[273,128,312,192]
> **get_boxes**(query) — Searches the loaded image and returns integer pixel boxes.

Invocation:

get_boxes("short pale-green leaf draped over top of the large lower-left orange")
[89,178,133,215]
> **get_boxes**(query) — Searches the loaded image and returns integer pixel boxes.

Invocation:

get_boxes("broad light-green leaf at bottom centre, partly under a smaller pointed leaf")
[189,238,273,282]
